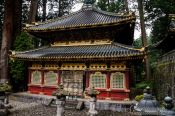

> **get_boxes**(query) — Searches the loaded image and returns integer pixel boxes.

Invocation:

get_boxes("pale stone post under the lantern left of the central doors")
[56,99,65,116]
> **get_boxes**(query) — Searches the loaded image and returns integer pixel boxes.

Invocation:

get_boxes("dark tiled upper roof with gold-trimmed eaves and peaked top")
[24,7,135,32]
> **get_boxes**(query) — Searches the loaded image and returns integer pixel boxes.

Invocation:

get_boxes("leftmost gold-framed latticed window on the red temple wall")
[31,71,42,84]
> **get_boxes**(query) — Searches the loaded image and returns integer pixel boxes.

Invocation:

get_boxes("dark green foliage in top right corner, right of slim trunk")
[145,0,175,43]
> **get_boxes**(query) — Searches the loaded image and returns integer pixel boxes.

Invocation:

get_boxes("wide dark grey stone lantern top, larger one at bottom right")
[134,87,159,115]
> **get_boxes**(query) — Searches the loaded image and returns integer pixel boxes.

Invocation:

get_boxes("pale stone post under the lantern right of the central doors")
[88,97,98,116]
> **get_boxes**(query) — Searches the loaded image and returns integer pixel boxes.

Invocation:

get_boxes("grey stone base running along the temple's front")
[10,92,135,112]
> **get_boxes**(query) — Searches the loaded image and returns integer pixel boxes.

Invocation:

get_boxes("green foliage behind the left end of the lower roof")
[9,32,34,91]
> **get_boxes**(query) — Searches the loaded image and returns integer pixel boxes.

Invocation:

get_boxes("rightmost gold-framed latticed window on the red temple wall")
[111,72,125,89]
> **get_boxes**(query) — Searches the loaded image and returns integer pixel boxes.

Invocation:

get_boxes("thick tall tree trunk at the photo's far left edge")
[0,0,14,83]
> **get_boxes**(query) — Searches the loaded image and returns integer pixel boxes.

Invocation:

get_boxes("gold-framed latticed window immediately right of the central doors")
[90,72,106,88]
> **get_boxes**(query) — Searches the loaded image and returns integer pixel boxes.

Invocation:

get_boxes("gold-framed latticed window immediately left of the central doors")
[44,71,58,85]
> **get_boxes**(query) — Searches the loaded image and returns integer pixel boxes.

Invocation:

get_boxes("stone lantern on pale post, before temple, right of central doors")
[86,87,100,116]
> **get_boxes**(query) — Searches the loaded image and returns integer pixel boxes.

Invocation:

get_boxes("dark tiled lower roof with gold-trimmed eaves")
[10,43,145,61]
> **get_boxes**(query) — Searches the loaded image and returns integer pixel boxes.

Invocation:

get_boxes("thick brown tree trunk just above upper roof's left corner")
[28,0,38,24]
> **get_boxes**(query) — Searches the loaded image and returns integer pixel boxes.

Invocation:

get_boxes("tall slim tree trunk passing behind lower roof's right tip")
[137,0,150,80]
